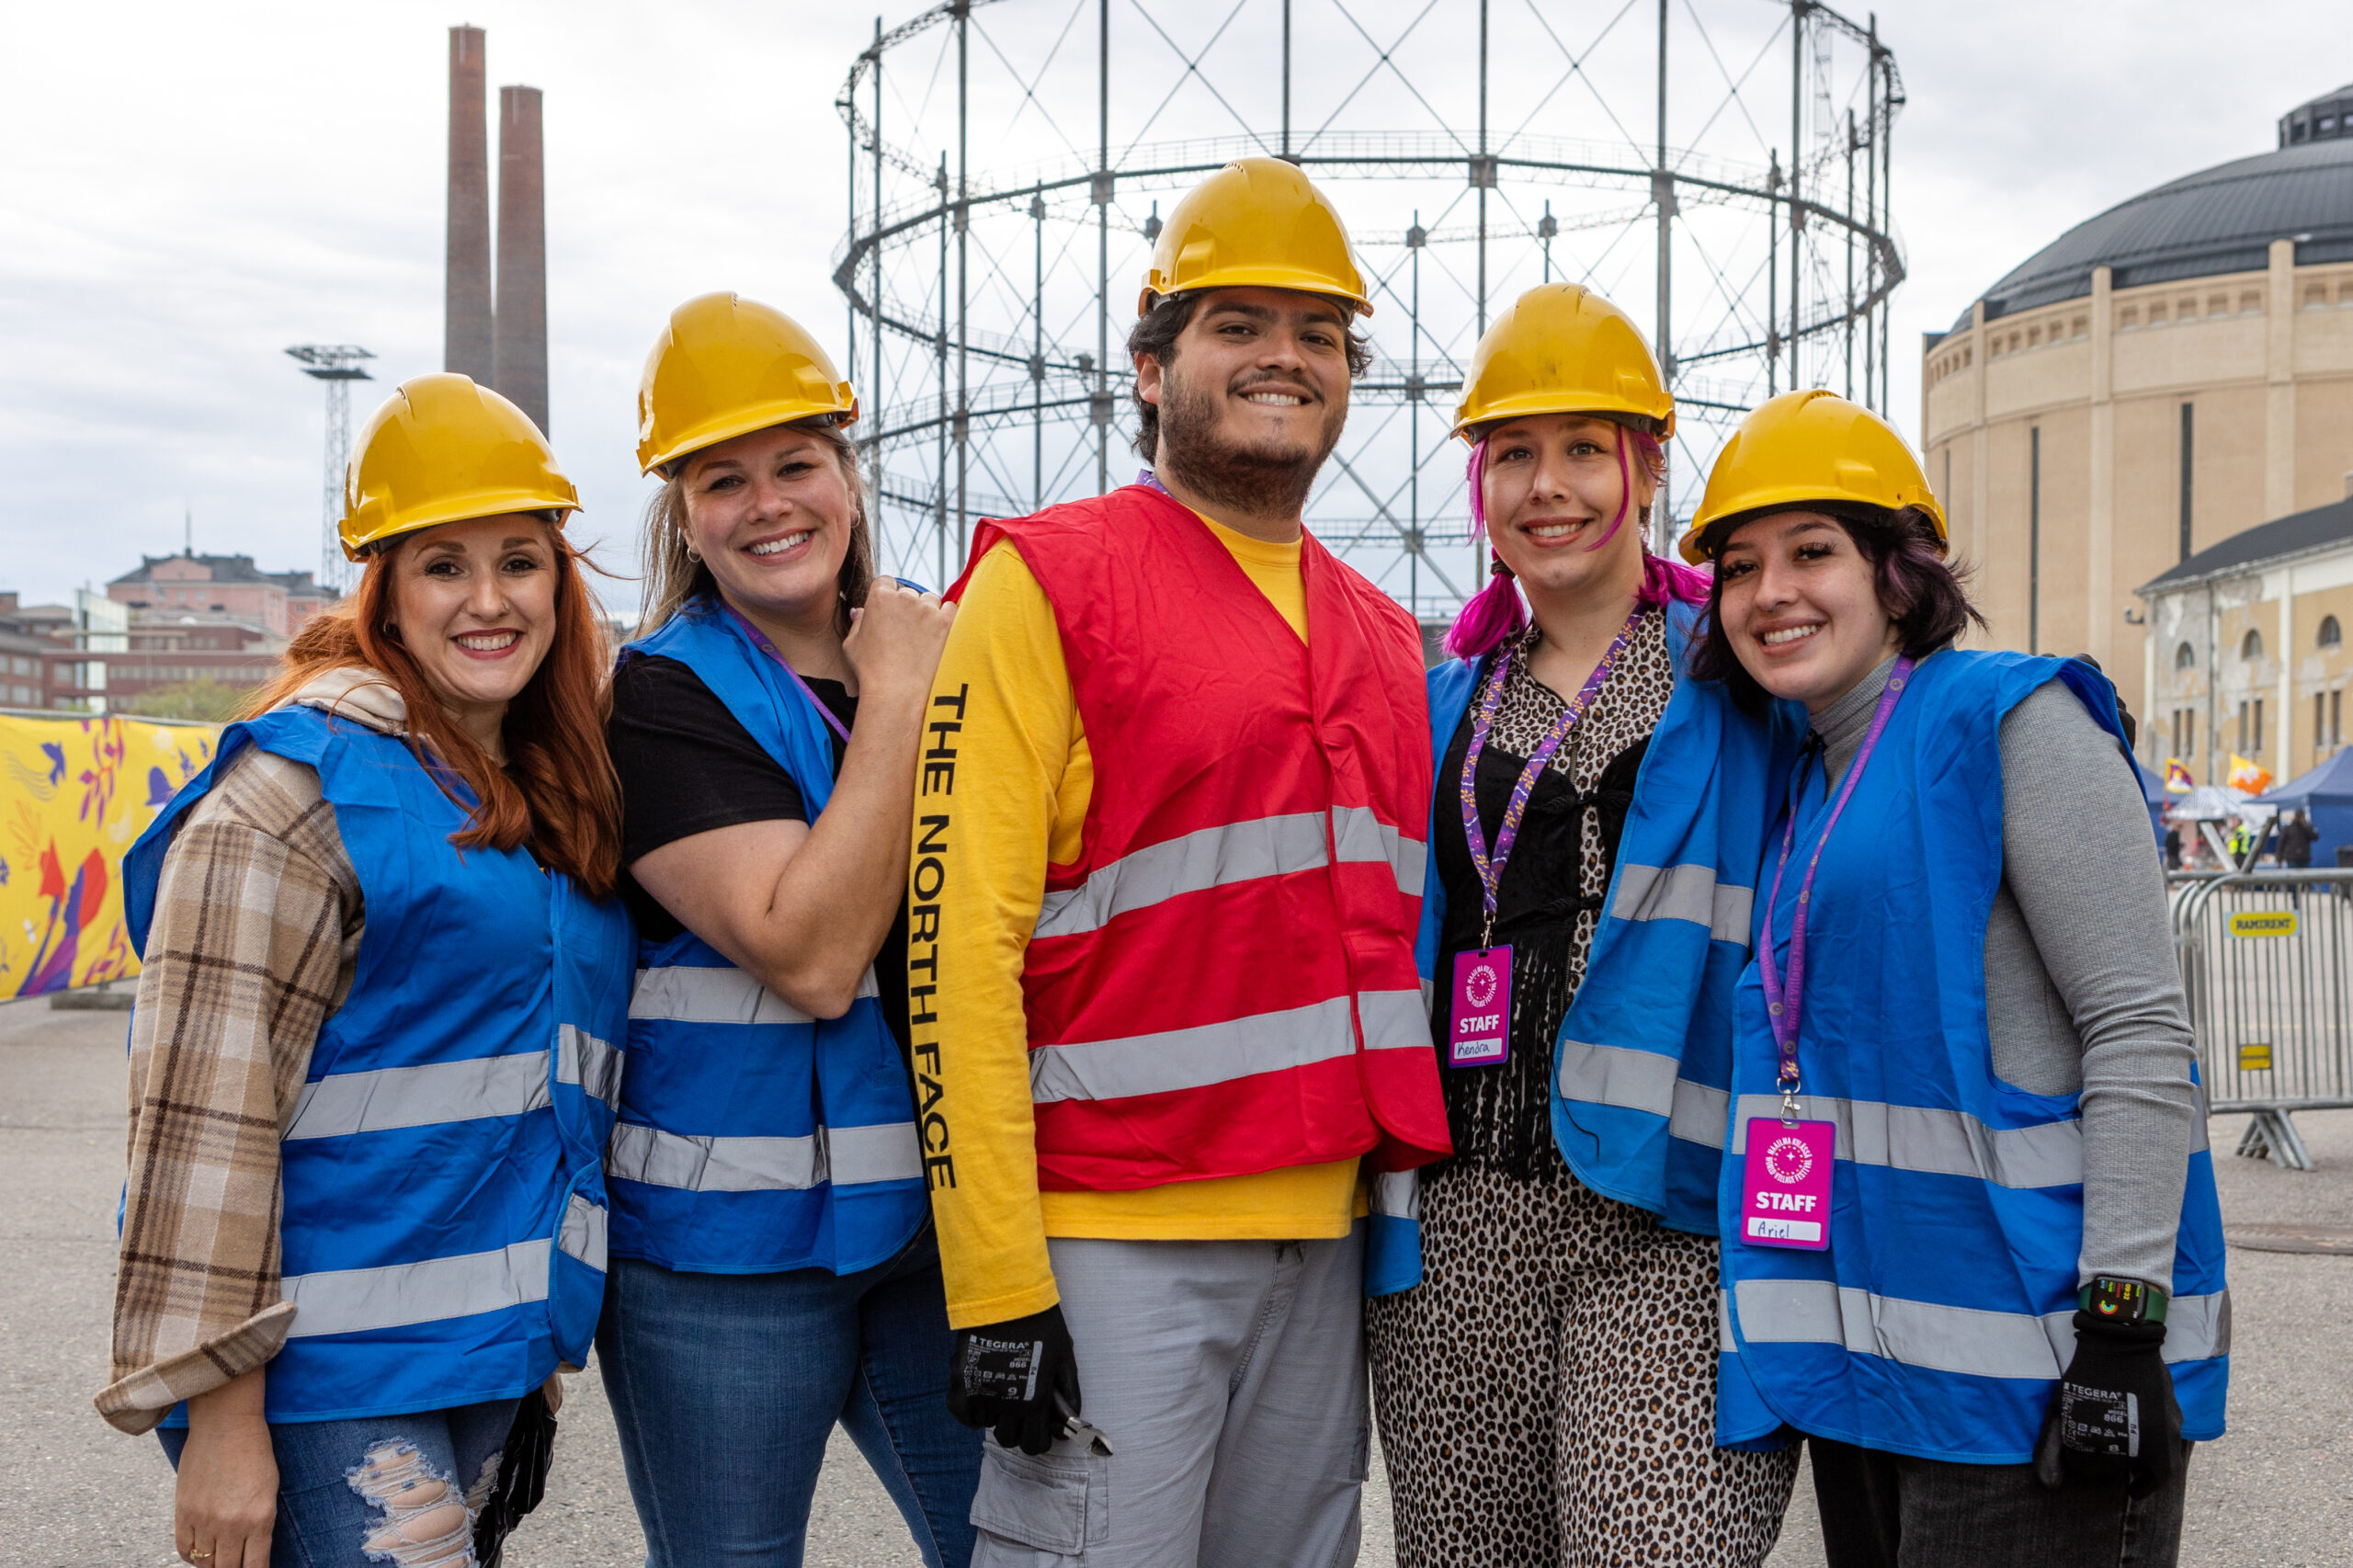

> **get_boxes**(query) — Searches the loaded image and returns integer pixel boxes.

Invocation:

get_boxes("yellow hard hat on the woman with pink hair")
[1454,282,1676,437]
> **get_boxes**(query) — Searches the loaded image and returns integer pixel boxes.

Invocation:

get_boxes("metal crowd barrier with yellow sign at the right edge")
[2167,869,2353,1170]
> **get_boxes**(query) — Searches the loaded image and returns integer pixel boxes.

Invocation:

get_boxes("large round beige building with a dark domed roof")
[1920,87,2353,784]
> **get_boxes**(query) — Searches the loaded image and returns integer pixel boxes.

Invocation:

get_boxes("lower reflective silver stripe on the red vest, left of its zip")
[1030,991,1355,1104]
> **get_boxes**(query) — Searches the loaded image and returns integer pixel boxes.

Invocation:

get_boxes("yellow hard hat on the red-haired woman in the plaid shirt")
[336,374,581,561]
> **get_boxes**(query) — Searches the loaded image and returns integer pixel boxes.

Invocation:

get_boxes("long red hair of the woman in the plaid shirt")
[240,525,621,900]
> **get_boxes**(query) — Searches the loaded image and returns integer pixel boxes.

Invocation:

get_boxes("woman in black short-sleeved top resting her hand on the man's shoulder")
[597,294,982,1568]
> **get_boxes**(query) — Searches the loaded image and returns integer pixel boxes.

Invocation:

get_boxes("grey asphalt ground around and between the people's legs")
[0,1001,2353,1568]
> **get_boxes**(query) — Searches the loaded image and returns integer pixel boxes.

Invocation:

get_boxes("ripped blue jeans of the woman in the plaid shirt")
[155,1399,517,1568]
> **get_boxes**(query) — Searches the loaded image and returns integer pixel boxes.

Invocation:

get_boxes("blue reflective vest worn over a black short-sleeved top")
[605,600,929,1274]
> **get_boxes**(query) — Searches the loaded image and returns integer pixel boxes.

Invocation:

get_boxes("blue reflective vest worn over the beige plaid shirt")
[122,706,633,1425]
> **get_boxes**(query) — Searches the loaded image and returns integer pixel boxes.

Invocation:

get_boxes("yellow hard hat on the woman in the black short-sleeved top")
[638,294,858,473]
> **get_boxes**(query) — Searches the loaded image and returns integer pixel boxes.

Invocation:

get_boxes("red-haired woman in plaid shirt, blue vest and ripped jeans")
[97,374,631,1568]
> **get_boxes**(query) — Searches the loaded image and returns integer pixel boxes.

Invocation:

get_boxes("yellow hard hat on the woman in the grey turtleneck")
[1682,389,1946,565]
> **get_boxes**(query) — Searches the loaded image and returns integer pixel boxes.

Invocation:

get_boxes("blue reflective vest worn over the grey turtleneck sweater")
[1718,653,2231,1464]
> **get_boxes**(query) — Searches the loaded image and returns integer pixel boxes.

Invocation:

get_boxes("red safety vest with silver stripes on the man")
[950,485,1452,1191]
